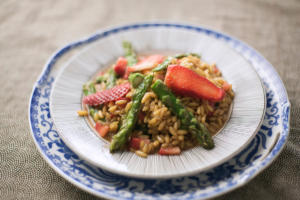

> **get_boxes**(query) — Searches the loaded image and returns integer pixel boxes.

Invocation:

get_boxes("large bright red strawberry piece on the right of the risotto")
[165,65,225,101]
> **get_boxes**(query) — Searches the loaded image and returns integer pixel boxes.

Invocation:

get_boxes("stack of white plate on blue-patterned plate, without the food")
[29,23,289,199]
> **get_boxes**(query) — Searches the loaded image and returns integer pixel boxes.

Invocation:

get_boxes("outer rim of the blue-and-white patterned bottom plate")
[28,22,290,198]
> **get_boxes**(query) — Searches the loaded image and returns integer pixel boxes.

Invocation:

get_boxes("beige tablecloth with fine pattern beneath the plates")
[0,0,300,199]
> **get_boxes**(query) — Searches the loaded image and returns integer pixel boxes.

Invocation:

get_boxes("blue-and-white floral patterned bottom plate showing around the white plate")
[29,23,289,199]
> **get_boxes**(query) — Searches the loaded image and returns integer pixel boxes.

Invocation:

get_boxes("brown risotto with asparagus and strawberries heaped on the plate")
[78,42,234,157]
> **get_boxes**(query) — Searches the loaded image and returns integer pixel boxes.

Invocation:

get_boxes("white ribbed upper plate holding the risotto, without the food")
[50,23,265,178]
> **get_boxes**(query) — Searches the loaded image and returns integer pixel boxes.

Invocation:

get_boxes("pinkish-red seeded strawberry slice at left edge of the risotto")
[83,83,130,106]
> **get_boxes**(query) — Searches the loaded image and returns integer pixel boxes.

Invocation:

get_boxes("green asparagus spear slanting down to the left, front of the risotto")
[110,74,153,152]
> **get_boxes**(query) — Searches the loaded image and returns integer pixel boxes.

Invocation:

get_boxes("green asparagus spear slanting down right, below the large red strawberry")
[151,80,214,149]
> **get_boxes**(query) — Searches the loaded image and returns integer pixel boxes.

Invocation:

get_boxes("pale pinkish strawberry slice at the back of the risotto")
[131,55,164,71]
